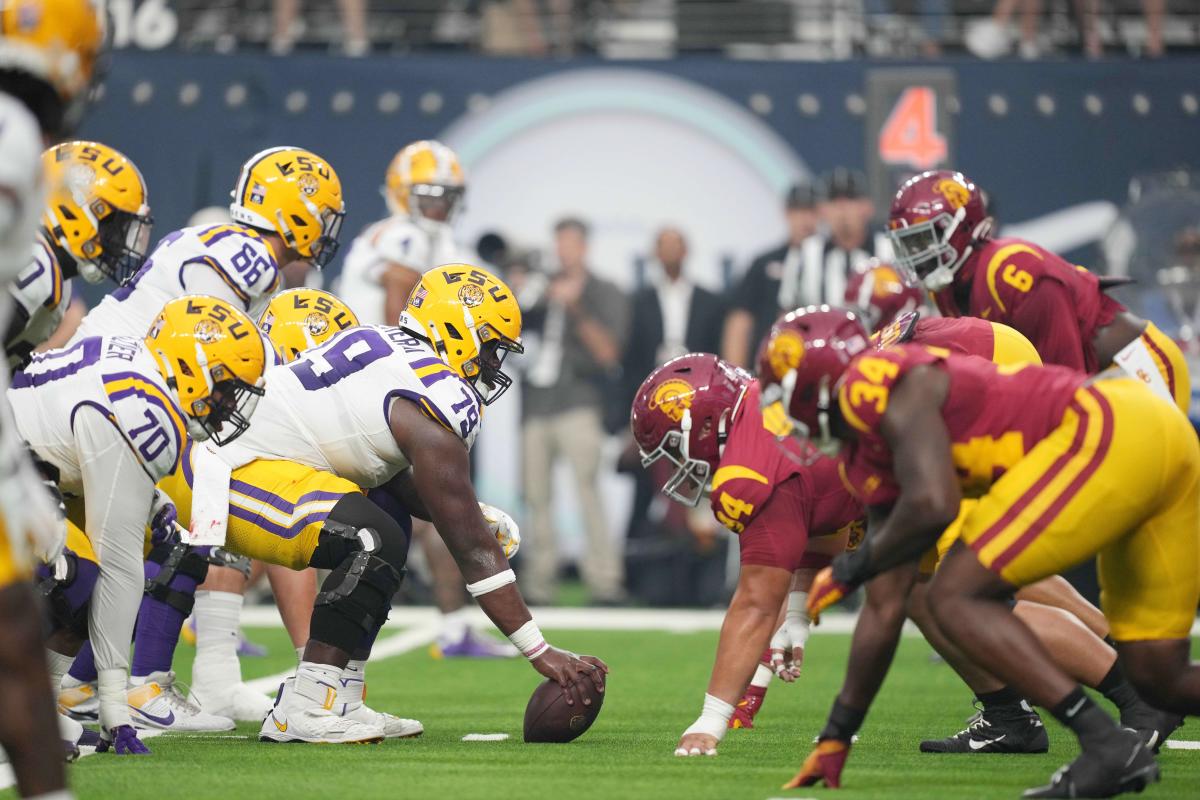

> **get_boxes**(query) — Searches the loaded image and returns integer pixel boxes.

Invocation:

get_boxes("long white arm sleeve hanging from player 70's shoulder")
[74,408,154,729]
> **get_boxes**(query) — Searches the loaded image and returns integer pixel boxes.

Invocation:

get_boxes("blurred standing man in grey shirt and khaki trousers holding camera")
[521,218,629,603]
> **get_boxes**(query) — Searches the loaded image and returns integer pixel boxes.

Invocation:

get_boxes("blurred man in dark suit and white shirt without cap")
[620,227,725,606]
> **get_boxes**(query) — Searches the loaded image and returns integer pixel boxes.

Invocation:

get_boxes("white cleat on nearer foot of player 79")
[258,678,385,745]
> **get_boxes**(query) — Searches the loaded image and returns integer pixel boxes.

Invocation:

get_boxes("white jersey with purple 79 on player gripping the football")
[215,325,482,488]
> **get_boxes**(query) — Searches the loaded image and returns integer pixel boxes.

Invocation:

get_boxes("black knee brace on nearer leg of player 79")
[311,521,404,652]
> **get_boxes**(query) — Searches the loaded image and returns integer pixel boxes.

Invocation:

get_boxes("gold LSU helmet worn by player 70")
[145,295,266,445]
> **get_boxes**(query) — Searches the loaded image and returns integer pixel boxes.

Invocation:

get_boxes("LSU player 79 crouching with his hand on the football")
[162,264,606,742]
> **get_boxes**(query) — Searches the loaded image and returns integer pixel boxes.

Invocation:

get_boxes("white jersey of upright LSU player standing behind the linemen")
[337,215,458,325]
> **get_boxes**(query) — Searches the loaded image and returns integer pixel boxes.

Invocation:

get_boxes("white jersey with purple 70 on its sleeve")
[8,336,187,494]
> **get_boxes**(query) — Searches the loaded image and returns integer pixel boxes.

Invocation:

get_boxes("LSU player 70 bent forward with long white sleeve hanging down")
[8,295,266,753]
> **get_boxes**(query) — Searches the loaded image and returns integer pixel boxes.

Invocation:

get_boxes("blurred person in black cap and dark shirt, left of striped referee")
[720,184,820,366]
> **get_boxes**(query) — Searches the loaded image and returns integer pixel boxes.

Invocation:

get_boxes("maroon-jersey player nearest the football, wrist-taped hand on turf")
[630,353,862,756]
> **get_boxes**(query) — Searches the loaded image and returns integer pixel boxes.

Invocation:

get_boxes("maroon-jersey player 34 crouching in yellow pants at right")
[760,308,1200,798]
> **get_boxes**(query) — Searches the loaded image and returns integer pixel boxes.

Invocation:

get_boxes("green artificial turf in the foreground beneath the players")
[42,630,1200,800]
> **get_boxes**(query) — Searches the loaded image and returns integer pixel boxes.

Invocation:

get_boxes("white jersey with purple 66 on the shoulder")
[71,223,281,343]
